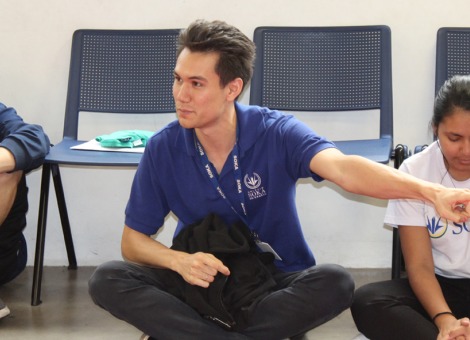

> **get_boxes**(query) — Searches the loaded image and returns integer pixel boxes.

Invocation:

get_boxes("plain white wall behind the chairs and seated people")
[0,0,470,268]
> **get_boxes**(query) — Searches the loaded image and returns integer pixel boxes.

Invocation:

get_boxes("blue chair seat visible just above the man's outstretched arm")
[334,138,393,164]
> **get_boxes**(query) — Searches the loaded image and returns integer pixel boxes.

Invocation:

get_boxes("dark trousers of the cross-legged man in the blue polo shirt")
[89,261,354,340]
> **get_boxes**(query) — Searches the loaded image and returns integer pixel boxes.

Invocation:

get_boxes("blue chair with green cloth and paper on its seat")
[31,29,179,305]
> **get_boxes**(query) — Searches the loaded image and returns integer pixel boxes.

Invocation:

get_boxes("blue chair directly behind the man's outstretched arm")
[250,26,393,163]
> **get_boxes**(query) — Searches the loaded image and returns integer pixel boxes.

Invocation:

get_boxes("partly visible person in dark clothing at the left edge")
[0,103,50,318]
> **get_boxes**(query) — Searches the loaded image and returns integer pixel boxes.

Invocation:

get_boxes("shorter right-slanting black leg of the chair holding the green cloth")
[51,164,77,269]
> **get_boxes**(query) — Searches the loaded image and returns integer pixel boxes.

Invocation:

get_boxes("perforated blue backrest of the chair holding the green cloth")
[64,29,179,139]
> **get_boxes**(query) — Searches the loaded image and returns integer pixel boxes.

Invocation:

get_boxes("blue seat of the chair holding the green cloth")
[44,139,142,166]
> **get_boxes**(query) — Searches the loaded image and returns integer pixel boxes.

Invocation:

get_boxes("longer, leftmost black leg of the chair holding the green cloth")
[31,163,51,306]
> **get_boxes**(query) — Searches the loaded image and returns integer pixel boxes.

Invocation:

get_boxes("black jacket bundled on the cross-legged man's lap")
[165,214,276,330]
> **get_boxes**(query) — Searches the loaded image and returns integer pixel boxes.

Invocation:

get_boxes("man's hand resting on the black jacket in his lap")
[176,252,230,288]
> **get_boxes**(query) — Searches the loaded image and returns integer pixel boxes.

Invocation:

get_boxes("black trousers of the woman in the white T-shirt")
[351,275,470,340]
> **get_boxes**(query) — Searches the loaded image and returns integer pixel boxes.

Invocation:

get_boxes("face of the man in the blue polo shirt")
[173,48,233,129]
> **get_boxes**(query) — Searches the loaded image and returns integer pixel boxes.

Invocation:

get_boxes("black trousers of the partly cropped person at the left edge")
[0,175,28,285]
